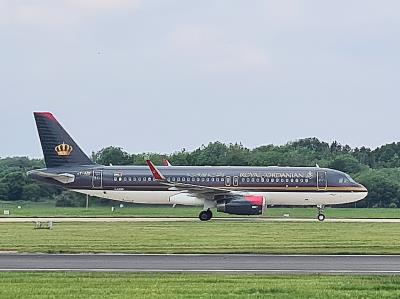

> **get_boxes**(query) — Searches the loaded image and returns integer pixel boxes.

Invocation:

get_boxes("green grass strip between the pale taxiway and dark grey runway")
[0,220,400,254]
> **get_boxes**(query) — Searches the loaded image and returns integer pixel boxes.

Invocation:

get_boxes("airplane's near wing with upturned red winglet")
[146,160,245,199]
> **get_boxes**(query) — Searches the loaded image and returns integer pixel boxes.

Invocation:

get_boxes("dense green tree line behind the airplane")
[0,138,400,208]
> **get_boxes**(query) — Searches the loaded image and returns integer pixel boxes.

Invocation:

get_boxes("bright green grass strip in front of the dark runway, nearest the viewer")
[0,273,400,299]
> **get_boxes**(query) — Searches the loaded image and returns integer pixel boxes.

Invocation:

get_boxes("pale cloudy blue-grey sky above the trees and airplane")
[0,0,400,157]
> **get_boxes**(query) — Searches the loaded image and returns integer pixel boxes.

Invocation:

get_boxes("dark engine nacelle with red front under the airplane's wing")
[217,195,265,215]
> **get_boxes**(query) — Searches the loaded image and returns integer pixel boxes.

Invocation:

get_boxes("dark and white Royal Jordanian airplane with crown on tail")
[27,112,368,221]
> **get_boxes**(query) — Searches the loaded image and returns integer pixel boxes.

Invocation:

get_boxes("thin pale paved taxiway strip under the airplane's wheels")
[0,217,400,223]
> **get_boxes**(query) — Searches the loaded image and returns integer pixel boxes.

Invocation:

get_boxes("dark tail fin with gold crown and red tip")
[34,112,93,168]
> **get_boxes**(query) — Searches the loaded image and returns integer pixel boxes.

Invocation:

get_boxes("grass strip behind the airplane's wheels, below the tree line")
[0,200,400,218]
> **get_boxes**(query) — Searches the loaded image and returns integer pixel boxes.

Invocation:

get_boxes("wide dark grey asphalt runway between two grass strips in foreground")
[0,254,400,275]
